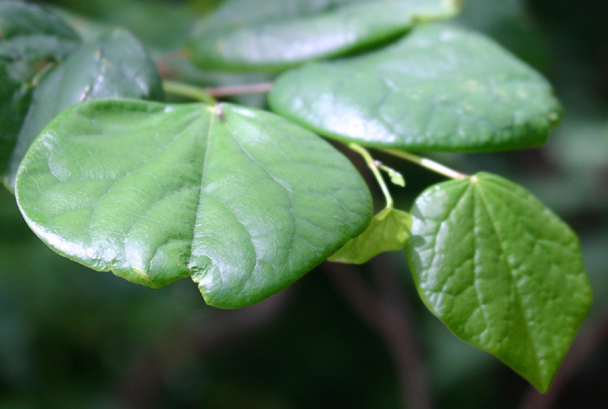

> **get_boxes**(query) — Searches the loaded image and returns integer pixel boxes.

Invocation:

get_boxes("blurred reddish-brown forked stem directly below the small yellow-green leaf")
[325,255,432,409]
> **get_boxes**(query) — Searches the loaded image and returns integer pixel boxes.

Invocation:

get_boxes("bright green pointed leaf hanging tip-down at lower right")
[406,173,592,392]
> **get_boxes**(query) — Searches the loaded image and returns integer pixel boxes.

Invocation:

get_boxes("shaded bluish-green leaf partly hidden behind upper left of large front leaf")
[4,29,163,190]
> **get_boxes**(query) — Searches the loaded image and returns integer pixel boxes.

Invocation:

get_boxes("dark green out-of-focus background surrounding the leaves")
[0,0,608,409]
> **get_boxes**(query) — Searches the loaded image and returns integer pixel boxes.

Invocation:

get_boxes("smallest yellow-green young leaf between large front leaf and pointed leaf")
[328,208,412,264]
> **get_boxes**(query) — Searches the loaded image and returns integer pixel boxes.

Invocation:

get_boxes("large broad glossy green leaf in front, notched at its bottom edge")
[16,100,372,308]
